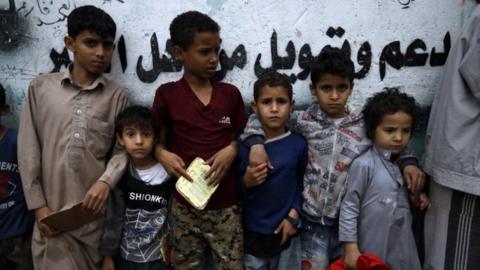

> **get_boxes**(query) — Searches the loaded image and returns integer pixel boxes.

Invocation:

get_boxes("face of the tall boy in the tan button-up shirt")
[65,31,115,76]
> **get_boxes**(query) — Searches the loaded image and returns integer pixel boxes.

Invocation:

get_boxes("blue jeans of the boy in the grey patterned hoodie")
[300,220,343,270]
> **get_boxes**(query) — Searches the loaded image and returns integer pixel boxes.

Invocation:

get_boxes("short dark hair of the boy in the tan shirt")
[67,6,117,39]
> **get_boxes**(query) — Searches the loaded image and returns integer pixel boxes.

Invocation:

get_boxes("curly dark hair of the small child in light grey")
[362,88,418,140]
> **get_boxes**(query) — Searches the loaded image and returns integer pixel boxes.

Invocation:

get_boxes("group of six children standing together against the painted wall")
[0,6,429,270]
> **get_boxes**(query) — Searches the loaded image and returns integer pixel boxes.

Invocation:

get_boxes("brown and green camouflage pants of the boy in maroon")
[171,200,243,270]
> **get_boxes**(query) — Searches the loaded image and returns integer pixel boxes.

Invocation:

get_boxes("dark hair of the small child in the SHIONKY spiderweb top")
[115,105,155,136]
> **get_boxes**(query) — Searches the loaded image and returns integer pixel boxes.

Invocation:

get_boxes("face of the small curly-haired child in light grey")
[373,111,413,154]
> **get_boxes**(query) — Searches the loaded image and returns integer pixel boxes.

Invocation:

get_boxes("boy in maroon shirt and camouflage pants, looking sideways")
[152,11,246,270]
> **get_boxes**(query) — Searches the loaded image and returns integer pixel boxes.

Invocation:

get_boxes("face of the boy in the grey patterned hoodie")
[310,73,352,119]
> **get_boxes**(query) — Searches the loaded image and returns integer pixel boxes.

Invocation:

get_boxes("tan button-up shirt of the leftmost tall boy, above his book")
[18,70,129,211]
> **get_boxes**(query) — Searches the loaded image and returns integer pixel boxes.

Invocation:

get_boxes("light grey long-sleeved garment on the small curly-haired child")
[339,147,421,270]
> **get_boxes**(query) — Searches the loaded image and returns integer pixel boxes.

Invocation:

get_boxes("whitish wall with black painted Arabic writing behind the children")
[0,0,475,143]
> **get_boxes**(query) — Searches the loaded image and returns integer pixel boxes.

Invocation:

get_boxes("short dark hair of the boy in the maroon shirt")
[170,11,220,50]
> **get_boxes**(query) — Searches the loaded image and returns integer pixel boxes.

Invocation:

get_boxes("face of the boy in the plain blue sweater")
[252,85,294,138]
